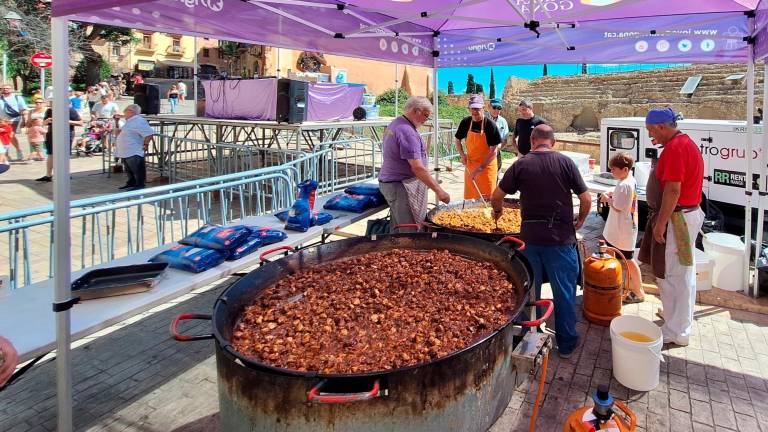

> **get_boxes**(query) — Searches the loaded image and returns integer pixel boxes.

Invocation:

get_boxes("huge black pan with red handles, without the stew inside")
[171,233,554,432]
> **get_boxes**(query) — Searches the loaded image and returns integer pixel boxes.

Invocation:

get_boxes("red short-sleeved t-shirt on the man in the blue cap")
[656,133,704,207]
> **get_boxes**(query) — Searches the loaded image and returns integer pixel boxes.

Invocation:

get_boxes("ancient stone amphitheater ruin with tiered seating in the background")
[496,64,763,132]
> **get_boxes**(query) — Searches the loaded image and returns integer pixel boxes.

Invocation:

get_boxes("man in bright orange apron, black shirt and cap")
[454,95,501,199]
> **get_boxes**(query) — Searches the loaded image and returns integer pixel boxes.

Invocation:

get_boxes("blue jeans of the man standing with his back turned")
[523,244,579,354]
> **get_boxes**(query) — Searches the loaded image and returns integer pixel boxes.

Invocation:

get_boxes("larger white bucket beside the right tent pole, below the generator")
[702,233,744,291]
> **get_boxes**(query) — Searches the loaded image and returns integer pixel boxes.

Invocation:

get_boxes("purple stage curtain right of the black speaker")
[307,83,365,121]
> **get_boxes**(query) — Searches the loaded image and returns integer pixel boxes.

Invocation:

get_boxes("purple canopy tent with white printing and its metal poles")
[52,0,768,431]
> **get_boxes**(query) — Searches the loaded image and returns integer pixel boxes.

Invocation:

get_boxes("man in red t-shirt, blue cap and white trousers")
[639,108,704,346]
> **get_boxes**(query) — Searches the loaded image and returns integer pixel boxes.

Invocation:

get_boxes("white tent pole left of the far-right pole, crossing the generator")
[743,25,755,296]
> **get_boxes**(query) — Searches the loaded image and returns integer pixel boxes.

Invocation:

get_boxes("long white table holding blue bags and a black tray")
[0,194,386,362]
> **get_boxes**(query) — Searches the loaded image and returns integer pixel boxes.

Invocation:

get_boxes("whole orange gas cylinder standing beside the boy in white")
[583,240,624,326]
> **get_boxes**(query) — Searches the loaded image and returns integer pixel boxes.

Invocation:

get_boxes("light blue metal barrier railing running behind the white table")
[0,149,342,289]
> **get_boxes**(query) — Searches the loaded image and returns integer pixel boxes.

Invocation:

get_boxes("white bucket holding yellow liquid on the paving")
[610,315,664,391]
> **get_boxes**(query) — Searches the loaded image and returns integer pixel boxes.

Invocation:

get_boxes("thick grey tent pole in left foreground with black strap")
[51,18,72,432]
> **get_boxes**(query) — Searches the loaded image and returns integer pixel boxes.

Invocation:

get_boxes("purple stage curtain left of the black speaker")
[203,78,277,120]
